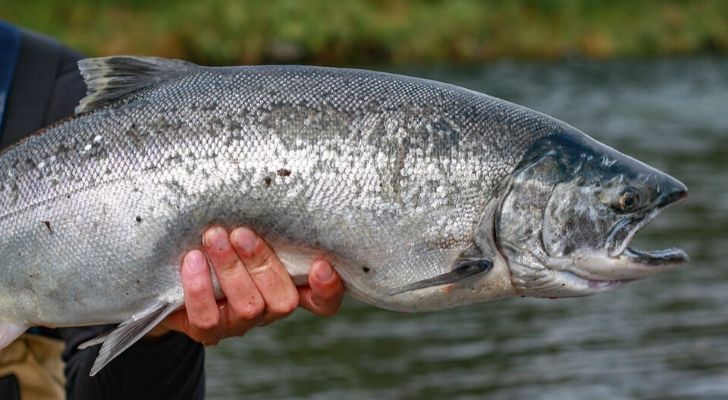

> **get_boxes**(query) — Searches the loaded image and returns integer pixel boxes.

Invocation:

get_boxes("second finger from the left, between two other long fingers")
[202,227,265,326]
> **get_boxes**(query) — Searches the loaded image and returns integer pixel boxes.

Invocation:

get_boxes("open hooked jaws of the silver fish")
[607,190,689,268]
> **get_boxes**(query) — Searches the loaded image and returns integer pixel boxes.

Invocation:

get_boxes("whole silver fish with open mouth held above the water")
[0,57,687,374]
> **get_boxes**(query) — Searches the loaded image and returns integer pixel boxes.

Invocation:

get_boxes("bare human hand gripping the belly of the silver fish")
[147,227,344,345]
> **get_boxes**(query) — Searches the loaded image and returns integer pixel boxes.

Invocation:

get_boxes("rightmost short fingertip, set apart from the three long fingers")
[299,260,344,317]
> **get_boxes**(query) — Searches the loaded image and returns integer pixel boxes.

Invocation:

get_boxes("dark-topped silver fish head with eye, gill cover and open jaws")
[494,131,688,298]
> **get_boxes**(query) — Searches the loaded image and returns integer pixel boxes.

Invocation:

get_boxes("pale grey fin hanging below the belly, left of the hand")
[78,300,182,376]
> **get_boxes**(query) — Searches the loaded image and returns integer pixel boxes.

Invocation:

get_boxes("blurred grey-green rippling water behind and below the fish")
[207,58,728,399]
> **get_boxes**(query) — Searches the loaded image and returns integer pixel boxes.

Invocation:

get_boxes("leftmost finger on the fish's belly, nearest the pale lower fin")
[180,250,221,344]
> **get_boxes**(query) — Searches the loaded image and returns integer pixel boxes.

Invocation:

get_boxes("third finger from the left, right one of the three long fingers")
[231,228,298,323]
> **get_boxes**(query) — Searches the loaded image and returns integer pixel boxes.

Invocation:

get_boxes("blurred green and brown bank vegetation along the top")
[0,0,728,64]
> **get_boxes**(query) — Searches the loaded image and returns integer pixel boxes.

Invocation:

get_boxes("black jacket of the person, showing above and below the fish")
[0,24,205,400]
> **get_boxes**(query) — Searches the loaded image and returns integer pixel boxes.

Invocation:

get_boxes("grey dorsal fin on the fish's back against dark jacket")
[76,56,199,114]
